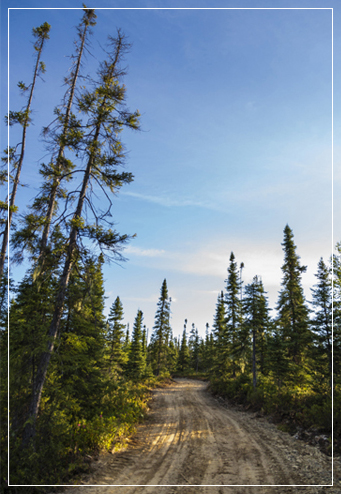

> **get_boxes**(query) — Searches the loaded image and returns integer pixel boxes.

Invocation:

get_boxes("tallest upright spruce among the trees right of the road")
[276,225,312,379]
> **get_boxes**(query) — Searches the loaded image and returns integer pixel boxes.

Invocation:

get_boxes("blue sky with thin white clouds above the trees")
[1,0,341,342]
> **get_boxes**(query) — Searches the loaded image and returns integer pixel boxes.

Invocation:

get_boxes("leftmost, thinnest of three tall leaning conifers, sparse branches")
[0,22,51,279]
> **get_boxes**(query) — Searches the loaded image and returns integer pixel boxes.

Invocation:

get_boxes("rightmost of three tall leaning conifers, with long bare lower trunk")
[23,31,139,445]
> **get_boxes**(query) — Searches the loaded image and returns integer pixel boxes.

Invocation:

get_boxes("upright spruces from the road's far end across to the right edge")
[103,225,341,404]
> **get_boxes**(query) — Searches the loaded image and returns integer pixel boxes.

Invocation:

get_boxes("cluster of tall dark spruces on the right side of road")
[207,225,341,391]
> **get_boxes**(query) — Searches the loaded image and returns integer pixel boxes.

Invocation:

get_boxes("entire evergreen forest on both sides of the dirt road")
[0,7,341,492]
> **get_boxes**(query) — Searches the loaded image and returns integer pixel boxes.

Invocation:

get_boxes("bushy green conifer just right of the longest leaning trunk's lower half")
[53,255,106,418]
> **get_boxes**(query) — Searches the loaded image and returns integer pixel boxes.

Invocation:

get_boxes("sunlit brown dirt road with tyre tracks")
[61,379,341,494]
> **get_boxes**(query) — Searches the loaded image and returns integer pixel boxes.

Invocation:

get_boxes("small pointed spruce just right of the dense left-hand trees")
[107,297,127,373]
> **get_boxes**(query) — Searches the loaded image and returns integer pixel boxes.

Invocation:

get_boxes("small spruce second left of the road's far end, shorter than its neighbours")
[127,310,146,381]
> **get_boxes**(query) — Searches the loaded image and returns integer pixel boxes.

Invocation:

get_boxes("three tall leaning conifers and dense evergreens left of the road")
[0,7,149,487]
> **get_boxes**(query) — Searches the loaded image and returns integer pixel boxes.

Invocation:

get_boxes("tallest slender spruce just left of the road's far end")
[151,279,171,376]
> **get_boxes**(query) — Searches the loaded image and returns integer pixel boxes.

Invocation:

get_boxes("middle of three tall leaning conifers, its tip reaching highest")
[12,8,96,278]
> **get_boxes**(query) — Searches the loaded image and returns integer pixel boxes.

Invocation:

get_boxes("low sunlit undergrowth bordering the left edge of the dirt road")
[1,375,169,494]
